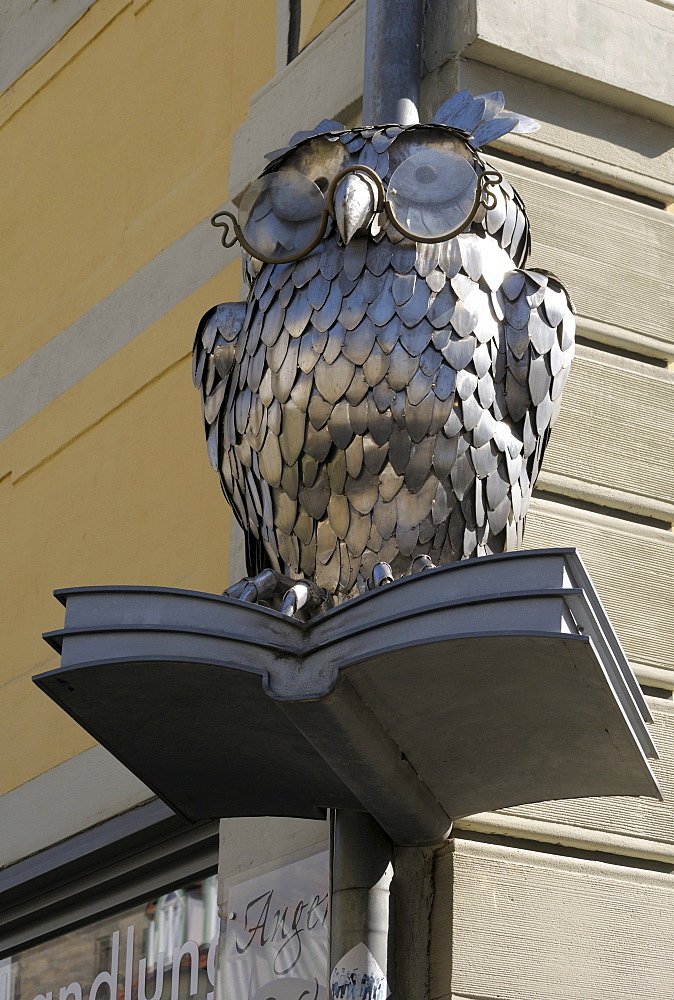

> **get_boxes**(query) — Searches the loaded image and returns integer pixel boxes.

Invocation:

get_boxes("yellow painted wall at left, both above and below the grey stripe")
[0,0,276,794]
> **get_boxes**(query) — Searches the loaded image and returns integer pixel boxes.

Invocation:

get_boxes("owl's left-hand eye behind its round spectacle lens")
[239,170,326,262]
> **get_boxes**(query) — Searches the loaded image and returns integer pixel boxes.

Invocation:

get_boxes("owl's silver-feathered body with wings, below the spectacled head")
[194,230,574,597]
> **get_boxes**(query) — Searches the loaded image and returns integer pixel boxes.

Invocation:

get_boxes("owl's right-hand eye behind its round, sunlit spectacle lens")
[386,149,479,240]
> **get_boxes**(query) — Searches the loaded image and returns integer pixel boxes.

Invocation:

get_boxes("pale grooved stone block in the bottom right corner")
[430,838,674,1000]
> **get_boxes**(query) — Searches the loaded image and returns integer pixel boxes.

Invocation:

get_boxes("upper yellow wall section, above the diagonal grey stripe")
[0,0,275,377]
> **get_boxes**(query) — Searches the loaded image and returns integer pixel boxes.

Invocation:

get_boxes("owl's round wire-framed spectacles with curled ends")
[211,149,503,264]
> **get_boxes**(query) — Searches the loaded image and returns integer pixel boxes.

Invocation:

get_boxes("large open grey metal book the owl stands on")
[37,552,659,844]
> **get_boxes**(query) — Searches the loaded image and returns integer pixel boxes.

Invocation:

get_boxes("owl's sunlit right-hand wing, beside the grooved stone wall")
[500,269,576,489]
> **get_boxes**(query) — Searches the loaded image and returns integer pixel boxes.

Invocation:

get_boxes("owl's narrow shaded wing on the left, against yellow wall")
[192,302,268,574]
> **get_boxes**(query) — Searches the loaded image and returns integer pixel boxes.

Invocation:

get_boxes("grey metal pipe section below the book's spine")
[330,809,393,995]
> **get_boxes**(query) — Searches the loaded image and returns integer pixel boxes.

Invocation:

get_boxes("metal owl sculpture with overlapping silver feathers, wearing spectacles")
[194,91,575,618]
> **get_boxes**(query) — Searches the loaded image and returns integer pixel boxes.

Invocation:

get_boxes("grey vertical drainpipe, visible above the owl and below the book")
[328,0,424,997]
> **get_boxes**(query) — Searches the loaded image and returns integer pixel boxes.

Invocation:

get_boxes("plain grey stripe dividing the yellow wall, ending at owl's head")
[0,211,238,441]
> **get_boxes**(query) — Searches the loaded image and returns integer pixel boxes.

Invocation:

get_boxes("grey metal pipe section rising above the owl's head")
[363,0,424,125]
